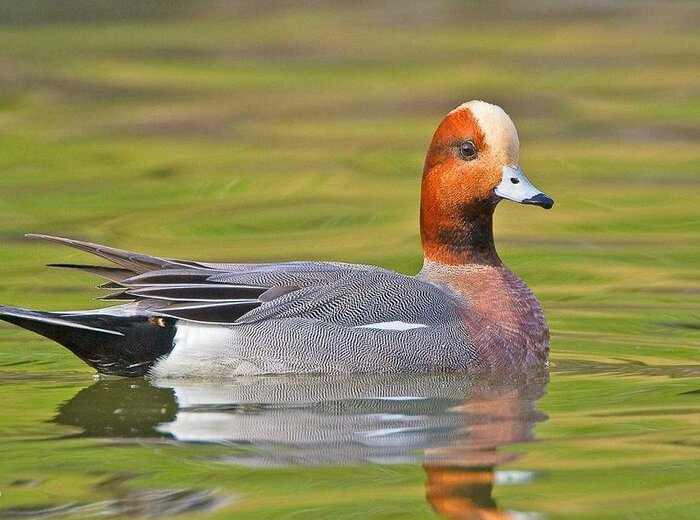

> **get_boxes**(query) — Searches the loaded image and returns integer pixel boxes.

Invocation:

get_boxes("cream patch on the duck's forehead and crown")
[455,101,520,166]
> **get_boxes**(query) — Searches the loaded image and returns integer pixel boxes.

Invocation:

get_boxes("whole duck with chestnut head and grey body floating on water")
[0,100,554,378]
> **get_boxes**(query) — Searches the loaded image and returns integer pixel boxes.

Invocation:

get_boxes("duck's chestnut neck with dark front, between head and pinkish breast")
[420,196,503,267]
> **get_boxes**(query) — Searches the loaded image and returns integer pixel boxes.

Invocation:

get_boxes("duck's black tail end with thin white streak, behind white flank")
[0,305,175,376]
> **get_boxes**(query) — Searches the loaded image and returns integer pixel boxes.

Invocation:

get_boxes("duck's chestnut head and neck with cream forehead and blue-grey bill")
[421,101,554,264]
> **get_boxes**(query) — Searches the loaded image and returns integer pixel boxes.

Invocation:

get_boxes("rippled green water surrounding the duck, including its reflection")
[0,0,700,519]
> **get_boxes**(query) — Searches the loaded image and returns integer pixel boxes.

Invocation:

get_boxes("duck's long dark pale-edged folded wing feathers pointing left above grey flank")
[28,234,378,324]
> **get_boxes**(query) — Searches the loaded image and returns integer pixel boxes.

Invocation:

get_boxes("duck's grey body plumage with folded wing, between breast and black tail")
[0,237,540,377]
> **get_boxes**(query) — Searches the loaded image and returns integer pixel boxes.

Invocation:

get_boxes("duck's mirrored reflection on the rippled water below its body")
[55,373,547,518]
